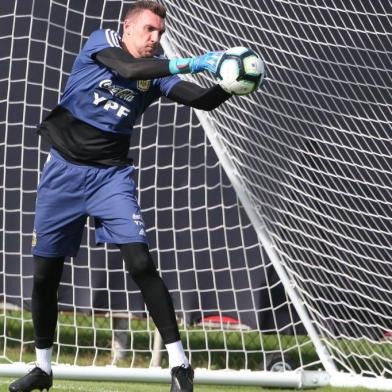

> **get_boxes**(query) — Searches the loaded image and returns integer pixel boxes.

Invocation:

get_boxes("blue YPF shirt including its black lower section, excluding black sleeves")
[38,29,181,166]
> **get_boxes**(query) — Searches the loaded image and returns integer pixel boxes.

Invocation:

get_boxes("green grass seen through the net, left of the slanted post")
[0,311,319,370]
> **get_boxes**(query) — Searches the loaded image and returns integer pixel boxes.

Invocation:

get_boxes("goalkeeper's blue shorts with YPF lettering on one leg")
[32,149,147,257]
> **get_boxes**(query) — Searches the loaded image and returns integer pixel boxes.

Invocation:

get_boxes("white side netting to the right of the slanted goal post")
[161,0,392,377]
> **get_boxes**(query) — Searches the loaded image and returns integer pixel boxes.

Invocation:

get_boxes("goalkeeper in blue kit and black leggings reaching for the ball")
[9,1,234,392]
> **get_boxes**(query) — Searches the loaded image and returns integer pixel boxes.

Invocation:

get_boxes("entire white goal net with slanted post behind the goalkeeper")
[0,0,392,390]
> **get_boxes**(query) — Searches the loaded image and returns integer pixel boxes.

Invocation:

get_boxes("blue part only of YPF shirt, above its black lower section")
[60,29,181,134]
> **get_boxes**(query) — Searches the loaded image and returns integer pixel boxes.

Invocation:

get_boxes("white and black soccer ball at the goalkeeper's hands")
[216,46,265,95]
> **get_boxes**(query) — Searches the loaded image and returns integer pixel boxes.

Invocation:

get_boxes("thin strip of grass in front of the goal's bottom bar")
[0,378,374,392]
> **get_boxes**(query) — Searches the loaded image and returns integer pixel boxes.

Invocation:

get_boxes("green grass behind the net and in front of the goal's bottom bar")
[0,311,392,392]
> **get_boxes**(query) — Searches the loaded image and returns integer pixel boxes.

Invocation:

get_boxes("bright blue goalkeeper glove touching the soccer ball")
[169,52,224,76]
